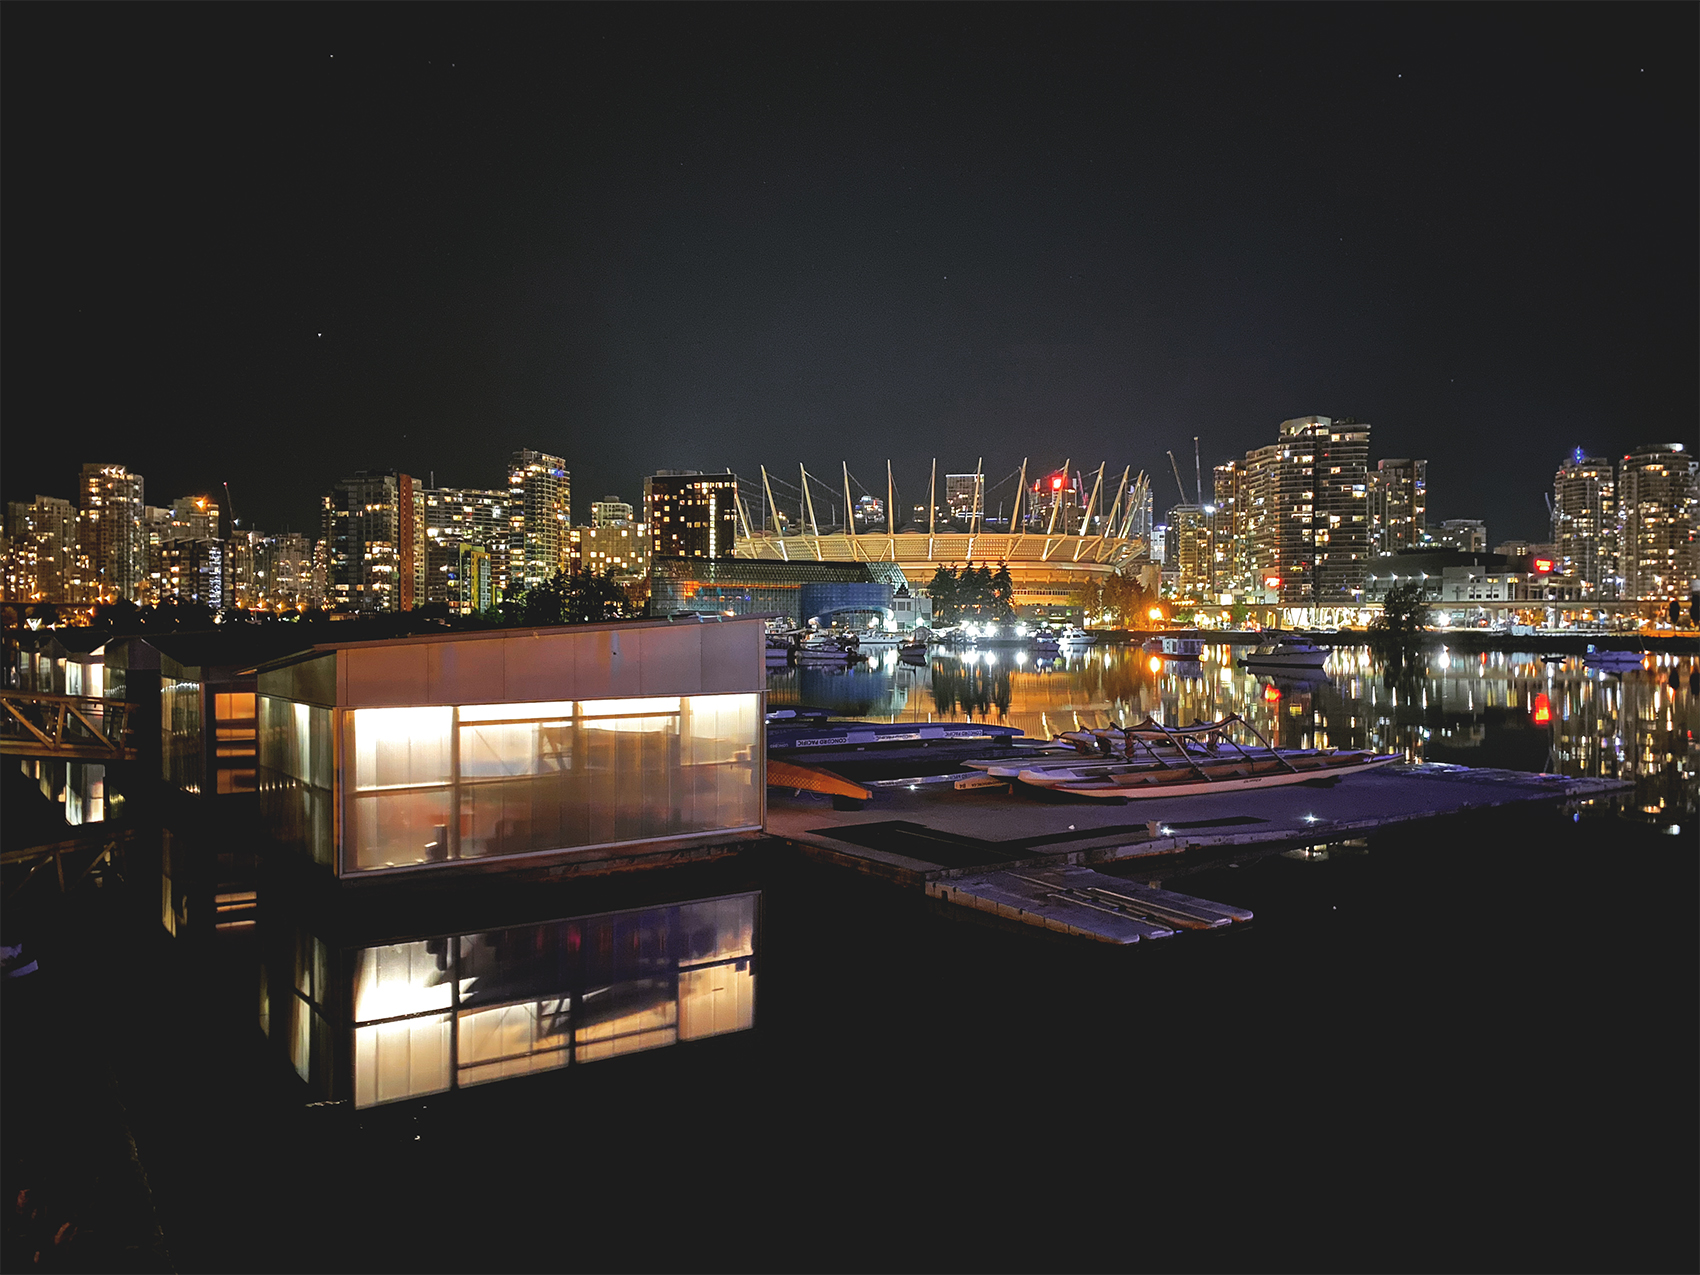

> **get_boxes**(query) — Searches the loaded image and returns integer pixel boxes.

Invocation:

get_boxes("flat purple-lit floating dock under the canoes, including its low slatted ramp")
[767,763,1634,944]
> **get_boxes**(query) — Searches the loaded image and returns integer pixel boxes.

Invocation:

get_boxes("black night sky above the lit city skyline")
[0,3,1700,541]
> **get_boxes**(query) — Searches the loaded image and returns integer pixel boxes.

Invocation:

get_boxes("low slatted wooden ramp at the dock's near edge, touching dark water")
[927,865,1251,945]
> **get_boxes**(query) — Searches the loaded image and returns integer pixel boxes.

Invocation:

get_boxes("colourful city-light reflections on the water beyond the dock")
[768,646,1700,816]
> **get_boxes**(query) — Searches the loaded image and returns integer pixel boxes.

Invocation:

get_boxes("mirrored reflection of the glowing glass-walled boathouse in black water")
[260,893,760,1107]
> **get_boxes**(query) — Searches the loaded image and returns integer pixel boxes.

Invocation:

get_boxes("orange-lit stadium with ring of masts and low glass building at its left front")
[651,461,1151,622]
